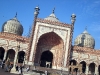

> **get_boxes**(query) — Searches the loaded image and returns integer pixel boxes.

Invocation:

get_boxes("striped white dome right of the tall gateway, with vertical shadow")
[74,29,95,48]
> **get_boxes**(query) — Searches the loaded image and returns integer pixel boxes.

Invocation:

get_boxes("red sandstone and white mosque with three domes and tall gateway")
[0,7,100,75]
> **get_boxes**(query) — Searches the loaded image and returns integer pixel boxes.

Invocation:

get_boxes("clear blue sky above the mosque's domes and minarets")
[0,0,100,50]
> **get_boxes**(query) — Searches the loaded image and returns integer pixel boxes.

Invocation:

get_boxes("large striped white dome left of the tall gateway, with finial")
[2,13,23,36]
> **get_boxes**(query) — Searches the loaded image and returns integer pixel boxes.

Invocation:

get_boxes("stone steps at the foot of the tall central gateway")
[23,66,69,75]
